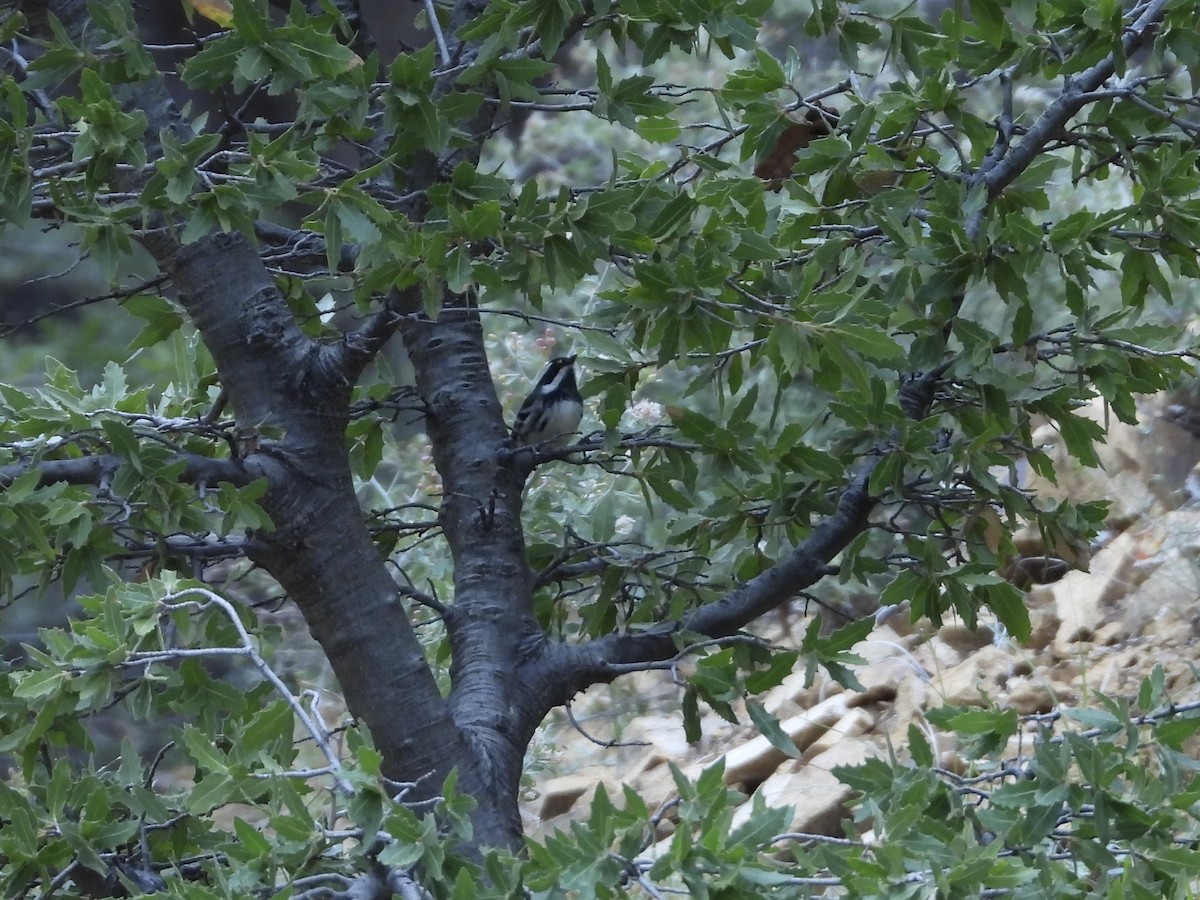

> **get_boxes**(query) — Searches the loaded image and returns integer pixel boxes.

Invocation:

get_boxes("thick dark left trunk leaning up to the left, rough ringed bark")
[150,234,475,792]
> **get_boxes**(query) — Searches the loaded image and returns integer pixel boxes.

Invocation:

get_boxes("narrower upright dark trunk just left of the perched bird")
[402,308,545,846]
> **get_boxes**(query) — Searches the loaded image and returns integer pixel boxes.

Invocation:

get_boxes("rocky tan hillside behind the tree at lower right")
[524,395,1200,838]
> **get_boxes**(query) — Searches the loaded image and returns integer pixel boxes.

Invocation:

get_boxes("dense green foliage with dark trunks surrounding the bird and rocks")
[0,0,1200,898]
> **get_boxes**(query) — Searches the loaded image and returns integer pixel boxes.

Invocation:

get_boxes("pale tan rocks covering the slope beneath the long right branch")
[522,398,1200,856]
